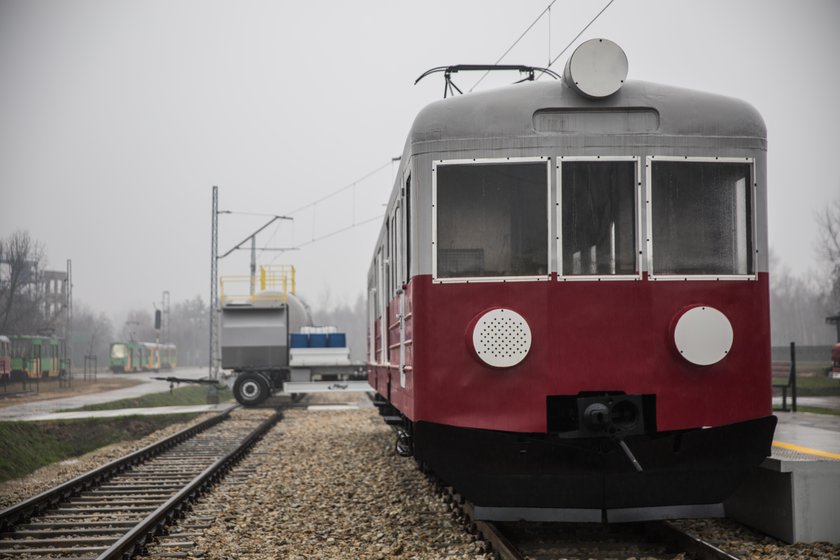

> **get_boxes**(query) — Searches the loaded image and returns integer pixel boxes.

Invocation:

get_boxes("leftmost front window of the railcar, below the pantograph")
[435,160,548,278]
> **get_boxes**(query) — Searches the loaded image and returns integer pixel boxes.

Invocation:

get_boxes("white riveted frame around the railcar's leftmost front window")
[432,156,552,284]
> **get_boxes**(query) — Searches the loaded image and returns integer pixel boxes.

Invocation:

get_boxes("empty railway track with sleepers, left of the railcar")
[0,411,282,560]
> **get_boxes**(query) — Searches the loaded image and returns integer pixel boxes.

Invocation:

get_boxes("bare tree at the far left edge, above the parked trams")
[0,230,48,334]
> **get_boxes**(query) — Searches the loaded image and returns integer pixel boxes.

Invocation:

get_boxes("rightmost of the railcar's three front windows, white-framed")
[649,158,754,276]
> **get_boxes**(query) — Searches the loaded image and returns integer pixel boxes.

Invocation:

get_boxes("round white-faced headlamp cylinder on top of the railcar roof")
[563,39,627,99]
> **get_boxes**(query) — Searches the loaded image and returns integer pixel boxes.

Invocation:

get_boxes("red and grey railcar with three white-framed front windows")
[368,40,776,521]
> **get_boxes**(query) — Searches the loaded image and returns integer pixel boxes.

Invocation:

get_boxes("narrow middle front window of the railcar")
[558,158,638,276]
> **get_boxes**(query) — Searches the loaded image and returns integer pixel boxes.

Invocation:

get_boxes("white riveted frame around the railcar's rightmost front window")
[645,155,758,282]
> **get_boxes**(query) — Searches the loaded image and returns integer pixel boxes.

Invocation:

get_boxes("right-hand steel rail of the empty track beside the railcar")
[96,410,283,560]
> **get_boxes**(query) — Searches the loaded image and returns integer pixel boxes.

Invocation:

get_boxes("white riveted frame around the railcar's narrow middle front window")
[555,155,643,282]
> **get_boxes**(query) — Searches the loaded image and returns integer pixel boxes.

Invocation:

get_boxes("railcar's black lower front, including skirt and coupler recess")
[374,394,776,520]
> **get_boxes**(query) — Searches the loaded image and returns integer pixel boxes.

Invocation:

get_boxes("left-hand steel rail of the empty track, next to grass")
[0,406,236,532]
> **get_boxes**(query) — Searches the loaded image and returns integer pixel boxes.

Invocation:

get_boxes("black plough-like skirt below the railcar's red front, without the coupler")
[411,416,776,510]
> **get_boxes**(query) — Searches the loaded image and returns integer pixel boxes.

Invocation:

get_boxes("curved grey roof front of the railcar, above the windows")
[409,80,767,148]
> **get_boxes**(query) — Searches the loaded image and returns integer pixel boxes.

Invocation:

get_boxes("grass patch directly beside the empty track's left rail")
[0,414,198,482]
